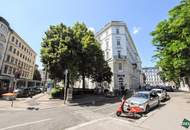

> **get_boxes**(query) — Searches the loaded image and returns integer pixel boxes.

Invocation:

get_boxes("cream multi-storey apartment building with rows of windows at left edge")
[0,17,36,79]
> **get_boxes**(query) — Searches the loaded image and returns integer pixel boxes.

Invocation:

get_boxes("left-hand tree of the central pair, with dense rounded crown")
[41,23,79,83]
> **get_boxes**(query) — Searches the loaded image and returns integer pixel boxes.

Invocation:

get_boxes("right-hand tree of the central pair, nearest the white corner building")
[72,23,110,89]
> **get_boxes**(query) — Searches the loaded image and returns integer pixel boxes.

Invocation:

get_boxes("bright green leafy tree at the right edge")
[151,0,190,87]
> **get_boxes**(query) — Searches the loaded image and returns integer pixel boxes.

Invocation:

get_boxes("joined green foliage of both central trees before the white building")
[41,23,112,88]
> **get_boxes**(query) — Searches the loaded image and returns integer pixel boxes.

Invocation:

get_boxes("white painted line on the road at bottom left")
[0,118,52,130]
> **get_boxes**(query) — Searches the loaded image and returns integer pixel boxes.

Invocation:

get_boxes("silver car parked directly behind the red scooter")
[123,91,160,113]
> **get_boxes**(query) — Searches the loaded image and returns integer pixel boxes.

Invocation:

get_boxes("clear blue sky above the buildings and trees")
[0,0,180,67]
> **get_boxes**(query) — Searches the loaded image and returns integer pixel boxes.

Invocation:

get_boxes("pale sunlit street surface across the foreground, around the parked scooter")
[0,92,190,130]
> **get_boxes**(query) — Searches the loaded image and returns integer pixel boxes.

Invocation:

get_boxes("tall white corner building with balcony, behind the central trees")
[96,21,141,91]
